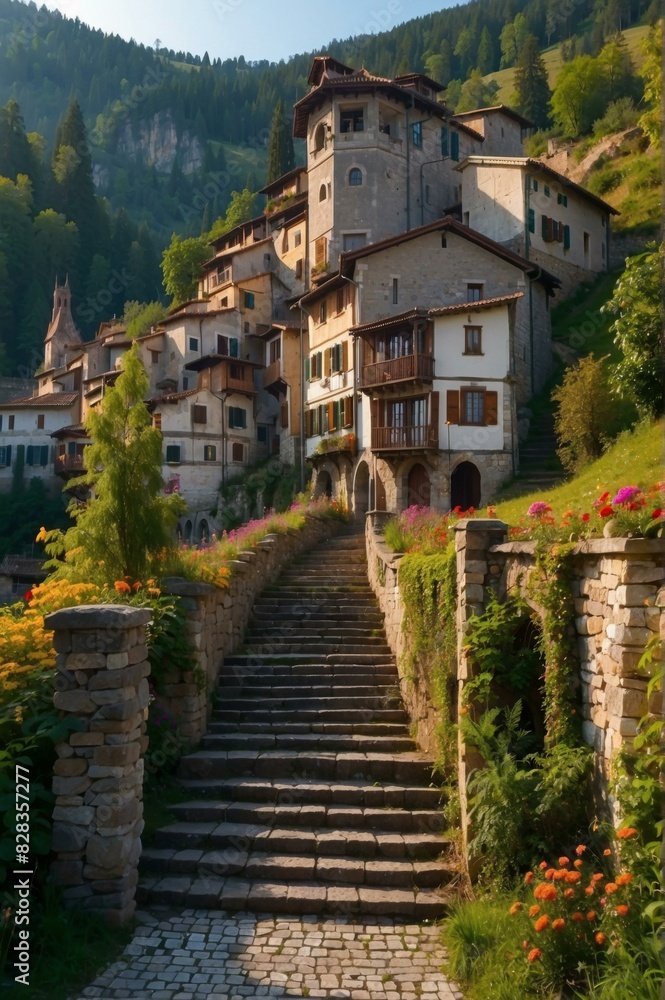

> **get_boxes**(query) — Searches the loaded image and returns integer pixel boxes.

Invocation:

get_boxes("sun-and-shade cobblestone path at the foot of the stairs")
[79,910,462,1000]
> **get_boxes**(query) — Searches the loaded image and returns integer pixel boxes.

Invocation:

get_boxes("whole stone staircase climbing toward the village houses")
[139,532,456,920]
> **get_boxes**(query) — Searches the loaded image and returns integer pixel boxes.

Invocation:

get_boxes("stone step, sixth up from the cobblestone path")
[178,750,434,784]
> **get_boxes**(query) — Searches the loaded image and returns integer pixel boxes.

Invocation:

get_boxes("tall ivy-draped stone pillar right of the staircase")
[455,518,508,875]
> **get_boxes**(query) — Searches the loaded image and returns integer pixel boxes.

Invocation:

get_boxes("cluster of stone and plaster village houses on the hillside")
[0,56,616,543]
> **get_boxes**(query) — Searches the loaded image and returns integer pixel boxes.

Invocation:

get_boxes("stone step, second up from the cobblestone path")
[144,842,454,889]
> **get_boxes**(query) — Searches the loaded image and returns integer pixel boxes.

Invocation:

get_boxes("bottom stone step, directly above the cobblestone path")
[137,875,449,921]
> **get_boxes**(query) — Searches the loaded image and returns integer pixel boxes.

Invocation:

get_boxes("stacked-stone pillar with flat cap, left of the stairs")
[44,604,151,925]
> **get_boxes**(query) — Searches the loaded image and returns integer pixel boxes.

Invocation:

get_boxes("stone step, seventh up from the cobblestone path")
[201,731,415,753]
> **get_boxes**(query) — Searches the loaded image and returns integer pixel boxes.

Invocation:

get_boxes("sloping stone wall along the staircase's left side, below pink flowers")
[157,515,341,744]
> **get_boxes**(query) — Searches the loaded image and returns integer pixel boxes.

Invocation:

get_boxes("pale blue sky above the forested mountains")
[45,0,455,61]
